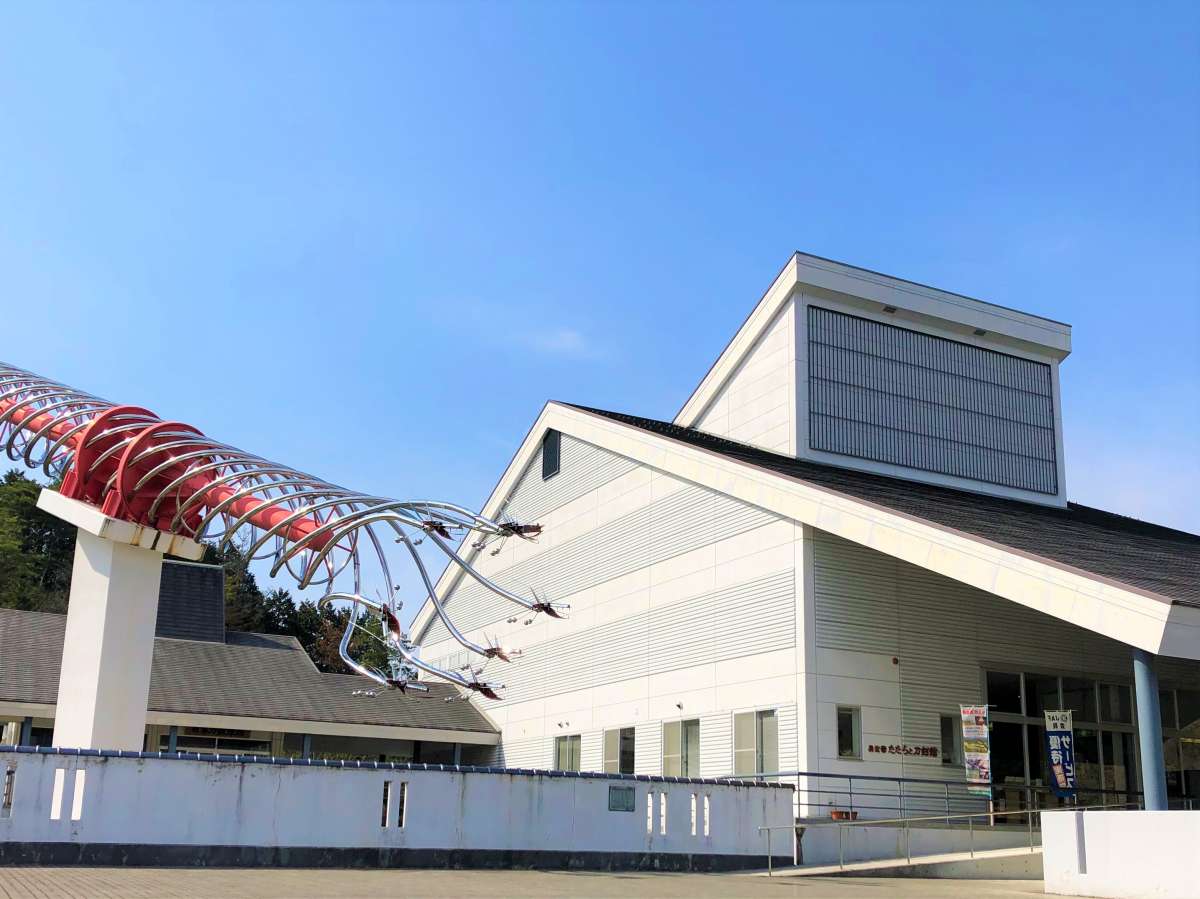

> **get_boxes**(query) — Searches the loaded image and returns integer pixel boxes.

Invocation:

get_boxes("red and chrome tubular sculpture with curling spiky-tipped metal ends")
[0,362,568,699]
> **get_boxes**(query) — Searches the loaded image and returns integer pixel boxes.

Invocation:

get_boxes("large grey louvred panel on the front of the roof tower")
[808,306,1058,495]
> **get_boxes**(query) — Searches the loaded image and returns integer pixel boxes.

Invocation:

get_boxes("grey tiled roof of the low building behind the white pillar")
[0,609,496,733]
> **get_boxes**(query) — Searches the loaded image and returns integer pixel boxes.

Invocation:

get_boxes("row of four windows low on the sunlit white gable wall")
[554,708,779,778]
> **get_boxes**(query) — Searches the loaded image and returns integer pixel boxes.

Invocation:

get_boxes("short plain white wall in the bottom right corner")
[1042,811,1200,899]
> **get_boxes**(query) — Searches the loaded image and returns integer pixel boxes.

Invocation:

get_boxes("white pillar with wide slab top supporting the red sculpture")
[37,490,204,750]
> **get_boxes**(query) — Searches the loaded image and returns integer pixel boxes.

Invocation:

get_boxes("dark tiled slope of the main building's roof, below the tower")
[575,406,1200,603]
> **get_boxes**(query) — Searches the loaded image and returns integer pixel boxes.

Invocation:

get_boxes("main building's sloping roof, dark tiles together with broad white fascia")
[413,403,1200,659]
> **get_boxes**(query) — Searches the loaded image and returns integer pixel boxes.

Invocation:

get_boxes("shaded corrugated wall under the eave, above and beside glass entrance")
[814,532,1200,779]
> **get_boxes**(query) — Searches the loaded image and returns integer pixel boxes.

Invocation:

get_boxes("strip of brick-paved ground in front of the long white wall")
[0,868,1043,899]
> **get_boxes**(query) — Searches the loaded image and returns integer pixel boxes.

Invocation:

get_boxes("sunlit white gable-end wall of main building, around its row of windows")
[422,436,796,777]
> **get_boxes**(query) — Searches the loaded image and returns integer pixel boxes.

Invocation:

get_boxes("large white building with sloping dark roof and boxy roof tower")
[414,253,1200,804]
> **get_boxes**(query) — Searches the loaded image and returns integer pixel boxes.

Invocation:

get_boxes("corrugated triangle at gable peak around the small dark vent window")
[500,434,637,523]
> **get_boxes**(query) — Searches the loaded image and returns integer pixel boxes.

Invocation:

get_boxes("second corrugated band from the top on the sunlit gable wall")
[421,480,778,646]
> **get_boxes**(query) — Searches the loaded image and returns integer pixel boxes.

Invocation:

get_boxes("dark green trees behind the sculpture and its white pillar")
[0,469,386,672]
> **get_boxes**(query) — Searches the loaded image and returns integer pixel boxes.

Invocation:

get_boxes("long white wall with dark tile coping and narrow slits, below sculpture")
[0,750,792,870]
